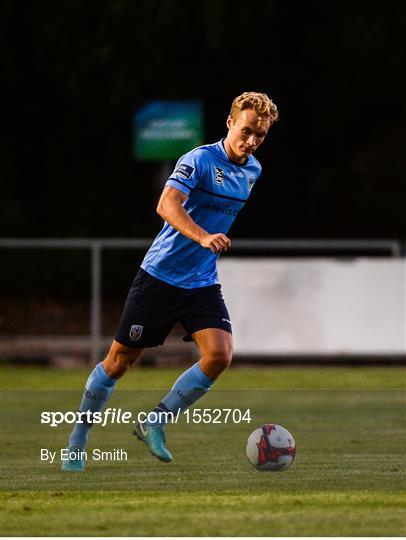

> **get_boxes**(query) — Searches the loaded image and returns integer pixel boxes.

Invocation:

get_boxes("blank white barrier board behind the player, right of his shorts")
[219,258,406,355]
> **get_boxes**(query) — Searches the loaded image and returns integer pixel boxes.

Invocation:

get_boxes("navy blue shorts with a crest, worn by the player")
[115,268,232,348]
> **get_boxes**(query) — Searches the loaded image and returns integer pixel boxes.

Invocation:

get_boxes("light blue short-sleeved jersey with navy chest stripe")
[141,140,261,289]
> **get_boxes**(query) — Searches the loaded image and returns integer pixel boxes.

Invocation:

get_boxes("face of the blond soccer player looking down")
[224,109,271,163]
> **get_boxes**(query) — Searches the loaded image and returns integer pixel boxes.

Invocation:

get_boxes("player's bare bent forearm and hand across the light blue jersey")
[156,186,231,253]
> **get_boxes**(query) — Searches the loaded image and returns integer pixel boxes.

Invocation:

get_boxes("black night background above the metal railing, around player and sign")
[0,0,406,238]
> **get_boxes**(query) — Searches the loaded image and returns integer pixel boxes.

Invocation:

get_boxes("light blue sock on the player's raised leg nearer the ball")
[147,362,214,426]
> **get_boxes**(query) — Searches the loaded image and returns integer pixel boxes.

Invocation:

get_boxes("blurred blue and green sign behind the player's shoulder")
[133,101,203,161]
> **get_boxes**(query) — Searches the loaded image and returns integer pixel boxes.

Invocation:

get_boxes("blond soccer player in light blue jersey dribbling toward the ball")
[62,92,278,471]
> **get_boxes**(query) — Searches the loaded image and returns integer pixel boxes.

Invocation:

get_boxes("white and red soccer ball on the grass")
[246,424,296,471]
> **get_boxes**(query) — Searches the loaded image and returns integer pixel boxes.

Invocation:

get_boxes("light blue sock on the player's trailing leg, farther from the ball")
[69,362,118,449]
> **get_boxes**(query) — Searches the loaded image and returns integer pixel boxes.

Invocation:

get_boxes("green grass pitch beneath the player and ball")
[0,362,406,536]
